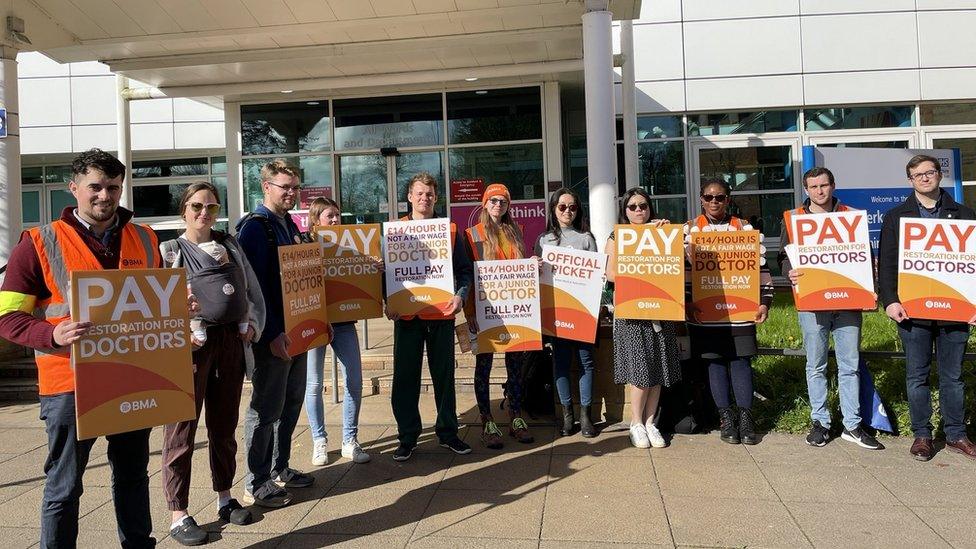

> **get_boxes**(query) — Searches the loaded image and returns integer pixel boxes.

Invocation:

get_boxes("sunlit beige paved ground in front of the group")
[0,395,976,549]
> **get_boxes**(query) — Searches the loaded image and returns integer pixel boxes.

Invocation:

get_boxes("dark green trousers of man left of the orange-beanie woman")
[390,318,458,445]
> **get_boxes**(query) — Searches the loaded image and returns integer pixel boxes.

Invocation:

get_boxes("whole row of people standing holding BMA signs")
[0,149,976,547]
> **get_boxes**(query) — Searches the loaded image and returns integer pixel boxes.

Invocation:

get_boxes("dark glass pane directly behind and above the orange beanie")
[449,143,546,200]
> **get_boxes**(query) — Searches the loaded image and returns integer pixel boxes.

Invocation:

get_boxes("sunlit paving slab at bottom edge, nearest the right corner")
[786,502,949,549]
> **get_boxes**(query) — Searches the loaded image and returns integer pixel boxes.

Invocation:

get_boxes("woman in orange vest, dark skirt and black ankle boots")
[685,179,773,444]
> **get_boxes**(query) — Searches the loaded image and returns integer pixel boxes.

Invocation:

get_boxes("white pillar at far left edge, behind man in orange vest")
[0,47,23,265]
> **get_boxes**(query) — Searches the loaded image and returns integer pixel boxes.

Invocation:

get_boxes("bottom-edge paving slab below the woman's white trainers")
[541,492,672,545]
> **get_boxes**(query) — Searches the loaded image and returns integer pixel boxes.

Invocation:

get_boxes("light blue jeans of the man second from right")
[797,311,862,430]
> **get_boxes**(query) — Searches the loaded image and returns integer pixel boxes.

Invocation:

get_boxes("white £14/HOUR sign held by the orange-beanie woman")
[474,259,542,353]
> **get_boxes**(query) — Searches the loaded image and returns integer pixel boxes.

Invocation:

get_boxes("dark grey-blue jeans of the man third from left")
[244,343,308,494]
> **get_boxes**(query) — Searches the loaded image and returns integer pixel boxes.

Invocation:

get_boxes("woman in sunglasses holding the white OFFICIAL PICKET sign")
[535,187,597,438]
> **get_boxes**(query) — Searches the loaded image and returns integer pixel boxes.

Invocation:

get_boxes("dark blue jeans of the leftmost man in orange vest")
[41,393,156,549]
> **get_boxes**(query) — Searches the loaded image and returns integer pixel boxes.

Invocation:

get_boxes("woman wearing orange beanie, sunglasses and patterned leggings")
[464,183,535,450]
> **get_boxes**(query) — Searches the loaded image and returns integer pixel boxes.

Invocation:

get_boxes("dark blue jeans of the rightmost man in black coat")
[898,320,969,441]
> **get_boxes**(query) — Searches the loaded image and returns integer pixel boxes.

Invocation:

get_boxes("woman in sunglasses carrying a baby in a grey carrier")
[159,182,264,545]
